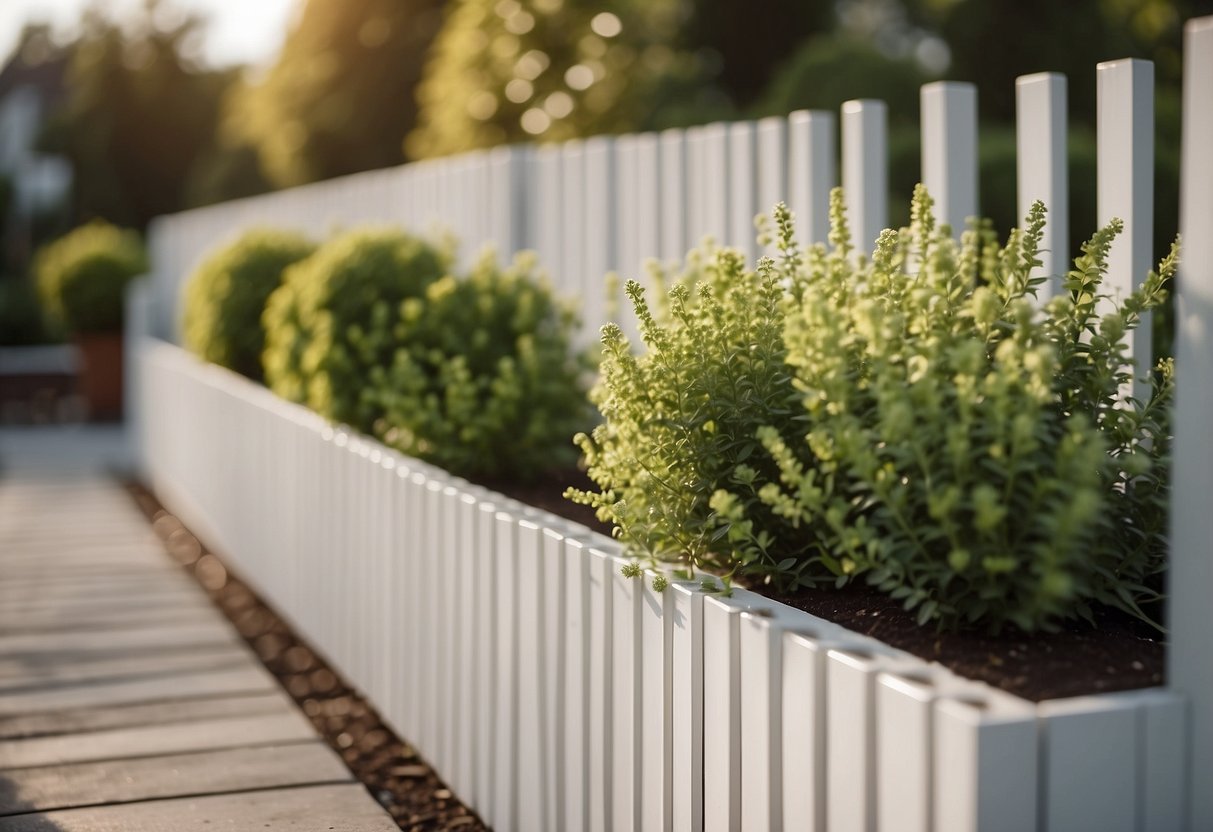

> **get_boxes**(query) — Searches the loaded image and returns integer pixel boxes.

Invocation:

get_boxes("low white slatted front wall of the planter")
[139,338,1186,832]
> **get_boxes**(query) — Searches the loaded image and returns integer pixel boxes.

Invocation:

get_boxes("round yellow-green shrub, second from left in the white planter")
[263,229,449,433]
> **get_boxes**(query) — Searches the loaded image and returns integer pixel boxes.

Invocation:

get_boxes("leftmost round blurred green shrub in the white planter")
[182,229,315,380]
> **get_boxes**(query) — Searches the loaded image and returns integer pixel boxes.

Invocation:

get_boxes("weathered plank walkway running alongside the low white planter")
[0,428,398,832]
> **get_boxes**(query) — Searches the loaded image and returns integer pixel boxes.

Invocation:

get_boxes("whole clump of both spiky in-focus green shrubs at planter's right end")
[569,188,1175,631]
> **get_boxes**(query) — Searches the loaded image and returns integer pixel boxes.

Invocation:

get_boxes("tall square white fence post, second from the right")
[1095,58,1154,399]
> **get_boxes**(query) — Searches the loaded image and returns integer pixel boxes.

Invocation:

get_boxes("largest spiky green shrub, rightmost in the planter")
[761,189,1175,631]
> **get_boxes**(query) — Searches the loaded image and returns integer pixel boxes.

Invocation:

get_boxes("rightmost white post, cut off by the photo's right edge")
[1167,17,1213,830]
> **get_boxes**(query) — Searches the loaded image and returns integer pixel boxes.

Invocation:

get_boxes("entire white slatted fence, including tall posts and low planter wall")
[130,18,1213,832]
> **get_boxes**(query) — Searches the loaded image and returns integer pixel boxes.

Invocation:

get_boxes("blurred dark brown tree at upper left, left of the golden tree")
[40,0,235,228]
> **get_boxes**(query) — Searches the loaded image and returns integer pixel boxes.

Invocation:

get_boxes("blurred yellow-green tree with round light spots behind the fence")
[406,0,835,158]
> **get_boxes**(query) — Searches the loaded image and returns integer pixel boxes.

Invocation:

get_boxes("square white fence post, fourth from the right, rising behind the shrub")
[921,81,978,239]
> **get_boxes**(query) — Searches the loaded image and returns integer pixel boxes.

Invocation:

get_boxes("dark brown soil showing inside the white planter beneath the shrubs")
[482,469,1166,702]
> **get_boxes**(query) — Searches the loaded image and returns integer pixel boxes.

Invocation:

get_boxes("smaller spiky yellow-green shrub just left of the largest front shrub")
[566,235,824,588]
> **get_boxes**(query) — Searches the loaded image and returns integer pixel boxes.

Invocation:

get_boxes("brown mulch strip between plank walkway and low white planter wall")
[127,483,488,832]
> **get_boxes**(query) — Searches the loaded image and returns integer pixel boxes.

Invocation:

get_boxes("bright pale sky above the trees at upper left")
[0,0,303,67]
